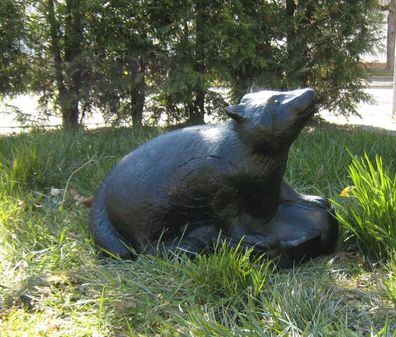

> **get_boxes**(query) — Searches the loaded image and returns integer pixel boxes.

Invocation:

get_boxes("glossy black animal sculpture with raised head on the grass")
[91,88,338,265]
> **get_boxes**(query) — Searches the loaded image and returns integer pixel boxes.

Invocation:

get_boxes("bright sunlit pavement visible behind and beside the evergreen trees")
[0,81,396,134]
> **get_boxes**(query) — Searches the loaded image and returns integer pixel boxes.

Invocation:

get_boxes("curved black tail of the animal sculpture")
[90,182,133,258]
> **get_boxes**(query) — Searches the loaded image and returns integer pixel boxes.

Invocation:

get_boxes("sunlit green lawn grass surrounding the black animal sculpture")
[0,125,396,337]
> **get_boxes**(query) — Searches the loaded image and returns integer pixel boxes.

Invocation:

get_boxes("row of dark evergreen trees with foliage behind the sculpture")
[0,0,381,127]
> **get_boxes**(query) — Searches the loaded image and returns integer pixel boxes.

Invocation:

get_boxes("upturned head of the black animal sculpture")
[226,88,315,151]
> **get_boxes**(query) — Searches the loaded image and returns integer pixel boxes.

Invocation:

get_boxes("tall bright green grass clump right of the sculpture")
[337,153,396,259]
